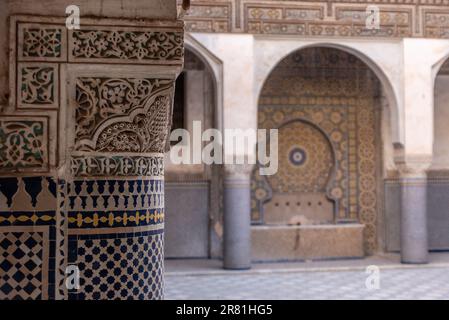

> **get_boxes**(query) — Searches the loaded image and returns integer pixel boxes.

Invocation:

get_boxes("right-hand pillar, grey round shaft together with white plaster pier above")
[399,39,438,263]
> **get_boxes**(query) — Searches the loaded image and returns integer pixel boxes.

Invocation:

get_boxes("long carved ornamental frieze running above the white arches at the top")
[178,0,449,38]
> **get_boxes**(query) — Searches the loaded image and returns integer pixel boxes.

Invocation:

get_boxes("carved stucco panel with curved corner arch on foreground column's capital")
[75,77,174,153]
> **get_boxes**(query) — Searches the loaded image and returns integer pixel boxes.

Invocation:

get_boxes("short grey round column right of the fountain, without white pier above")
[400,164,429,264]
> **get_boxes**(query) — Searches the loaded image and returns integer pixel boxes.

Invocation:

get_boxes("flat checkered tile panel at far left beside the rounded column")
[0,177,61,300]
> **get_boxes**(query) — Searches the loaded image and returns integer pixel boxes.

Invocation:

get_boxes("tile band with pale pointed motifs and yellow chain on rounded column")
[67,179,164,229]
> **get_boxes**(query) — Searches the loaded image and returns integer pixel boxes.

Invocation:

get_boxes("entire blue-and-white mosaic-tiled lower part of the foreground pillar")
[0,177,164,300]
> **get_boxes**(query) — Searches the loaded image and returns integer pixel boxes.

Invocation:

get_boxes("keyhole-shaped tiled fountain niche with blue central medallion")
[263,118,338,225]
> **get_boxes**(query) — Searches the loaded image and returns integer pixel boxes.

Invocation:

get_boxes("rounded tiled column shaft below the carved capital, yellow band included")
[67,177,164,300]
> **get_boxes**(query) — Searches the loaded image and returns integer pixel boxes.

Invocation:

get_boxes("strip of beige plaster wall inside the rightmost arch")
[432,75,449,170]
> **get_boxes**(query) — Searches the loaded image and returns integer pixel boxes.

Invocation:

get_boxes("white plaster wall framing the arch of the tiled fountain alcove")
[192,34,449,167]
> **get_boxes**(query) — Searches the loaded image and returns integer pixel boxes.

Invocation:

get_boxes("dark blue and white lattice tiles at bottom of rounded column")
[69,230,164,300]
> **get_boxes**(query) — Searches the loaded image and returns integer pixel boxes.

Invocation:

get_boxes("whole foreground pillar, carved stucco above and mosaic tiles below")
[0,16,184,299]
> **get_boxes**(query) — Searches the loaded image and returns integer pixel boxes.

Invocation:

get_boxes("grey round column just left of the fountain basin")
[223,165,251,270]
